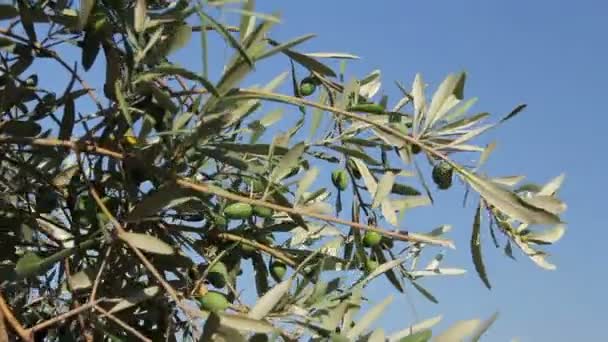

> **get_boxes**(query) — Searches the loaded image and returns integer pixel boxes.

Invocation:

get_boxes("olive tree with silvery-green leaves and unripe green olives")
[0,0,565,341]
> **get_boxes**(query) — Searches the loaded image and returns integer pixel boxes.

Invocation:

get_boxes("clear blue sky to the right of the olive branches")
[245,0,608,341]
